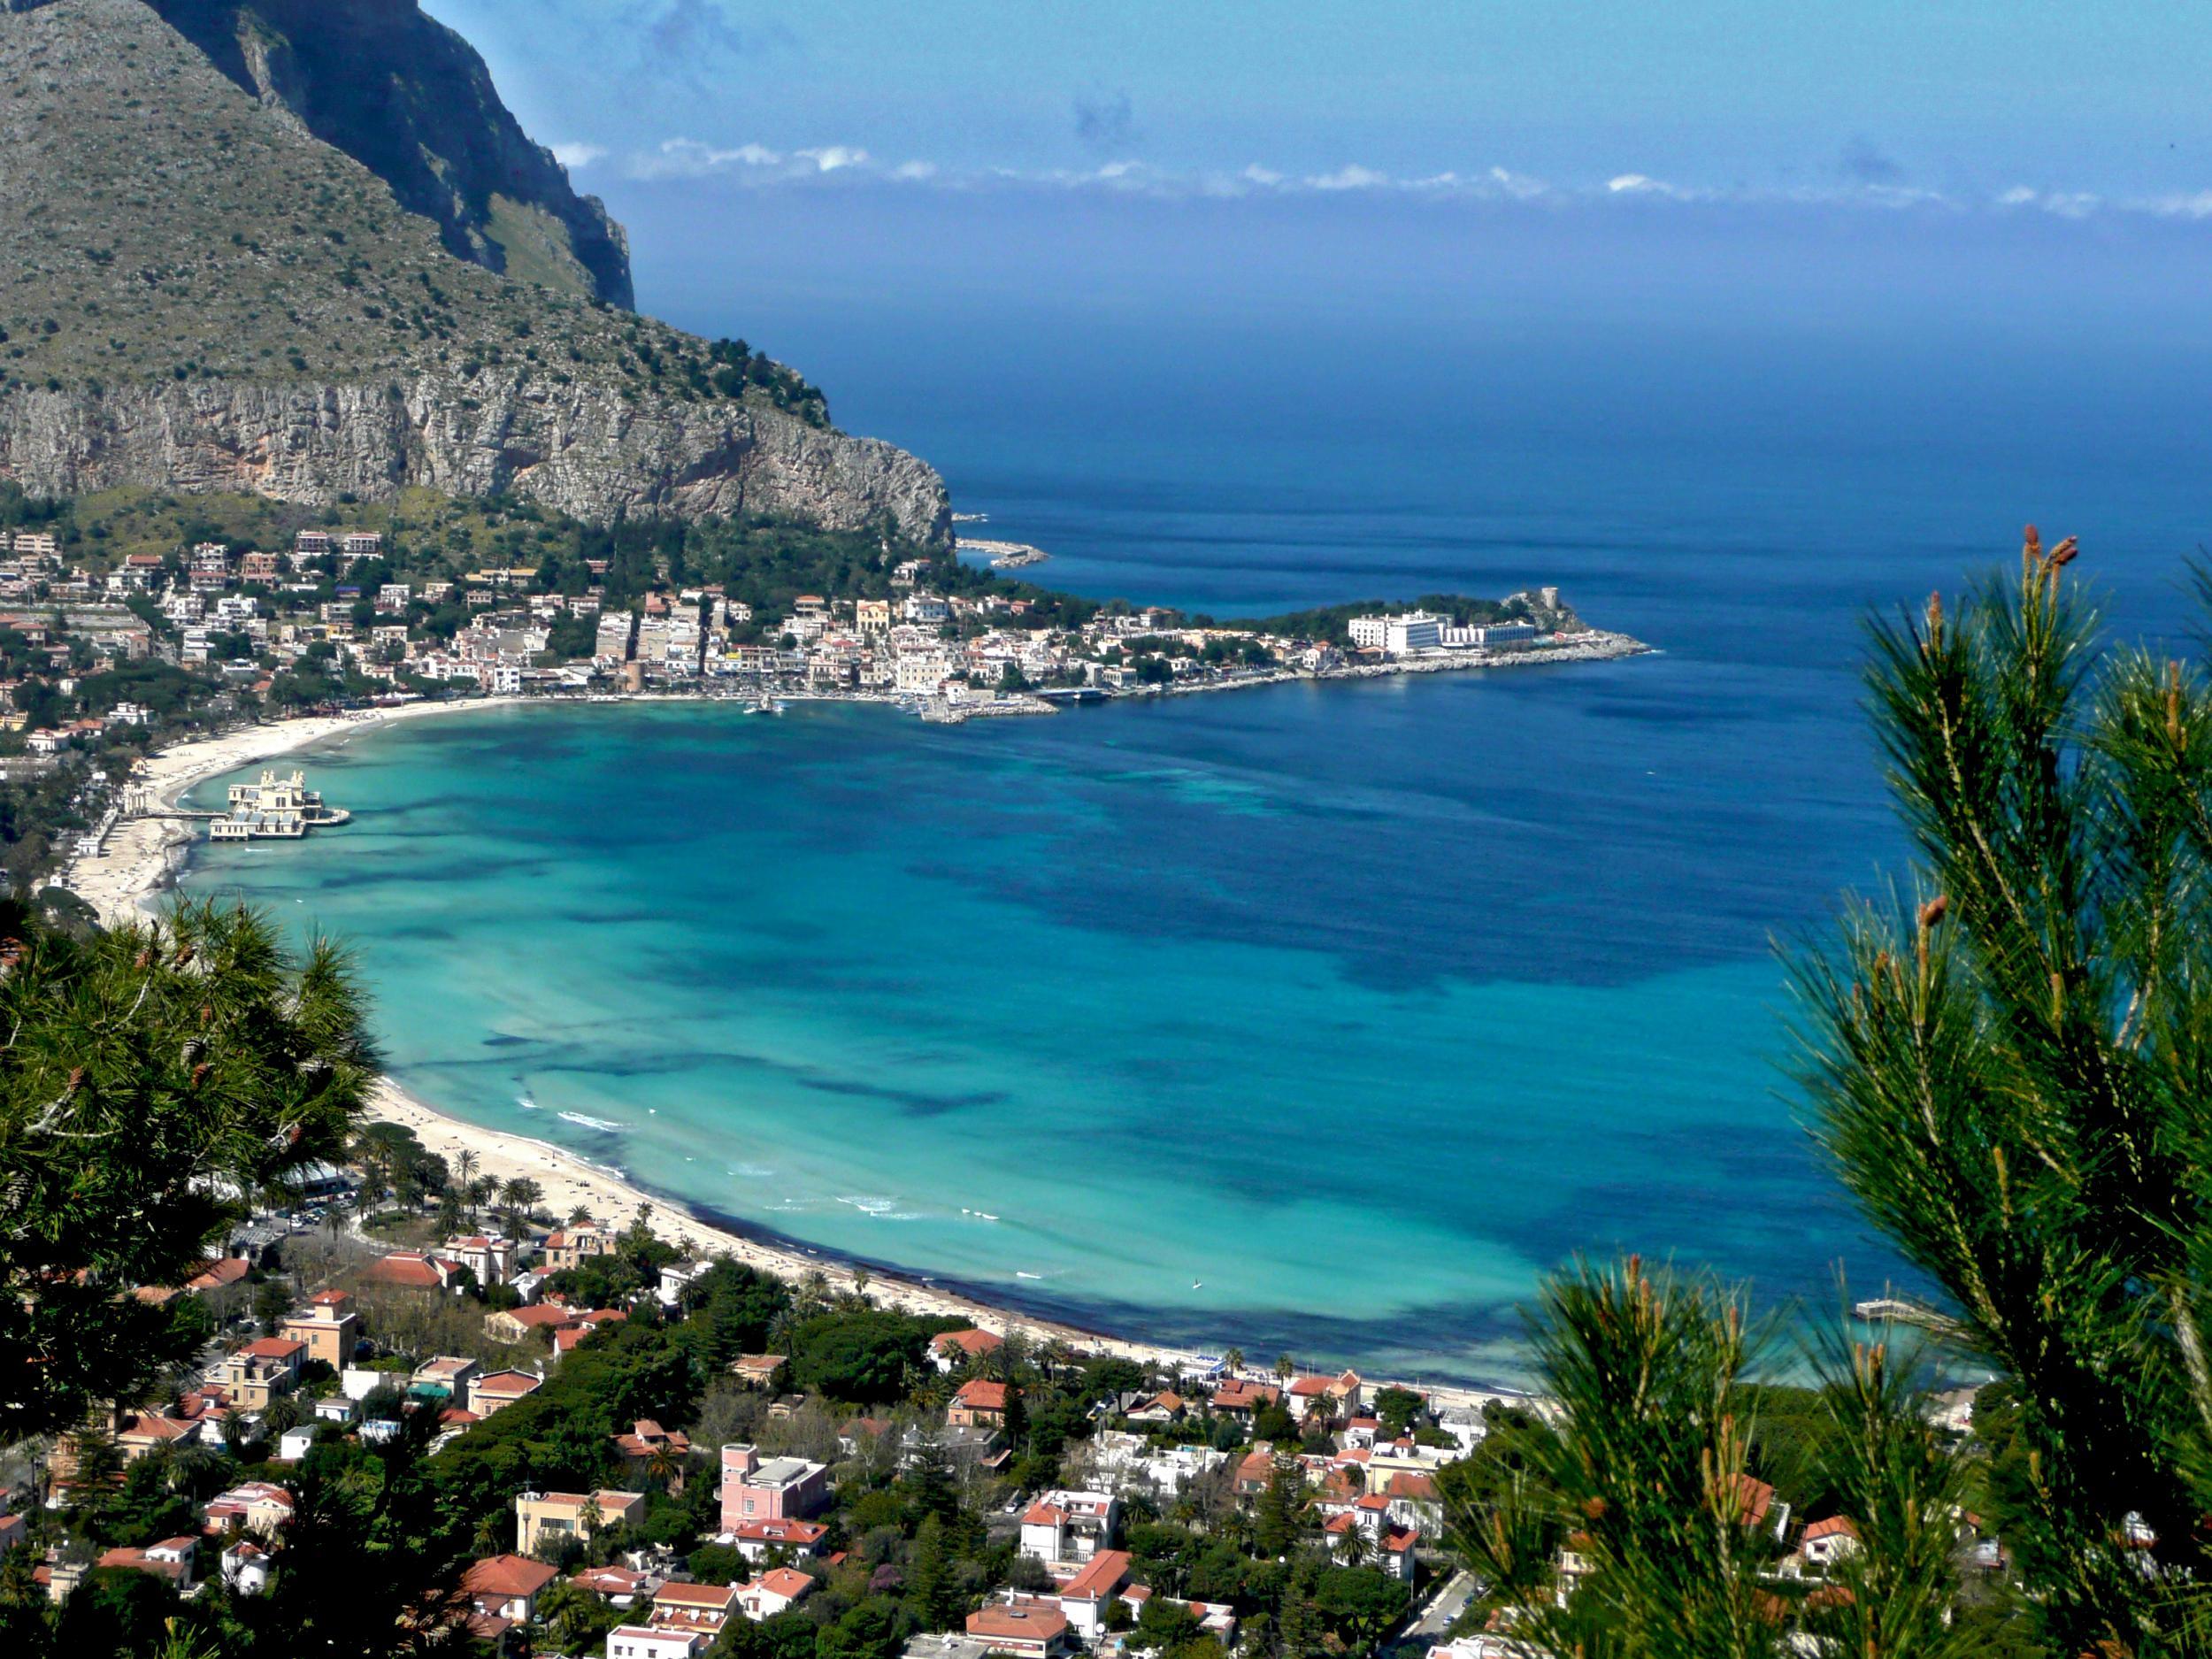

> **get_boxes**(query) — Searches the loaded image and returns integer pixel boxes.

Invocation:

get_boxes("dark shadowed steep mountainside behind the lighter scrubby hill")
[149,0,633,308]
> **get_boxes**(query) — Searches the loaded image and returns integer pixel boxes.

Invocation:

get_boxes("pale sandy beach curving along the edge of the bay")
[56,699,1500,1401]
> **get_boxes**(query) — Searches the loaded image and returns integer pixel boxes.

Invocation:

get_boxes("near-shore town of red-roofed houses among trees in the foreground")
[0,1122,2008,1659]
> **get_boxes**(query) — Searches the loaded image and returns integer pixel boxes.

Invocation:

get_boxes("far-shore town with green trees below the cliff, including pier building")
[0,498,1648,910]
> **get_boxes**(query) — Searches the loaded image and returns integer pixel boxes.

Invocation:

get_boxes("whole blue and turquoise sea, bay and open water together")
[188,234,2208,1383]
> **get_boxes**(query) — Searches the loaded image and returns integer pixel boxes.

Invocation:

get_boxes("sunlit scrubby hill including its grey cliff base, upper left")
[0,0,951,544]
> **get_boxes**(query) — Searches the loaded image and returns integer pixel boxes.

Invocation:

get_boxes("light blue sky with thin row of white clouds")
[429,0,2212,215]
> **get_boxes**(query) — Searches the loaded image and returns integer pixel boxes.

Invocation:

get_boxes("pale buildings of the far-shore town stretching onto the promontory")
[0,529,1640,734]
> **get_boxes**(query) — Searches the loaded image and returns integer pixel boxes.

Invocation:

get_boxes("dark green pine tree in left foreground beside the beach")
[0,905,376,1440]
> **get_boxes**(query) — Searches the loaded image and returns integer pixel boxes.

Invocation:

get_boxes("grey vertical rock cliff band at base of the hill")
[0,374,951,542]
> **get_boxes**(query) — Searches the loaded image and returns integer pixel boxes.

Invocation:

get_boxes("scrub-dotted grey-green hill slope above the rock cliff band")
[0,0,830,427]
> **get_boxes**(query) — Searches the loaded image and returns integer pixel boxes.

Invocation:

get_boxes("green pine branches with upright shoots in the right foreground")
[1445,529,2212,1659]
